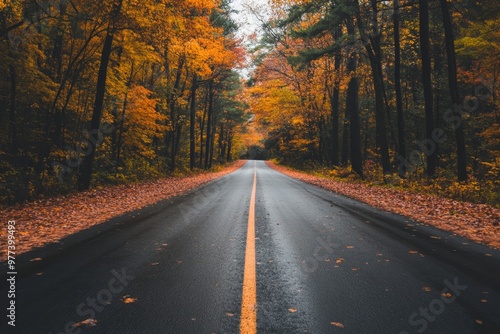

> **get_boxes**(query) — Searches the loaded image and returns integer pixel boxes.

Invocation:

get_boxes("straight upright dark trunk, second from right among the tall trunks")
[419,0,437,177]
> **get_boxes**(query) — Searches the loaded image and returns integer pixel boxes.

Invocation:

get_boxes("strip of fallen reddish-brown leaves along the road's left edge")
[0,160,246,261]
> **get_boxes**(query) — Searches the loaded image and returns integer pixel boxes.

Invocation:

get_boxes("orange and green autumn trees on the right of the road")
[246,0,500,205]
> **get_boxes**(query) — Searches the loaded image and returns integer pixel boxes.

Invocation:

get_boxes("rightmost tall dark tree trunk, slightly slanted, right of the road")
[439,0,467,181]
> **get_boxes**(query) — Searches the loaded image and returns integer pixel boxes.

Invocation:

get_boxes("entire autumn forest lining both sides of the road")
[0,0,500,205]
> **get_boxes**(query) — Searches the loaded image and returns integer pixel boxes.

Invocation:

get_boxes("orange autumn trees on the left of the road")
[0,0,249,203]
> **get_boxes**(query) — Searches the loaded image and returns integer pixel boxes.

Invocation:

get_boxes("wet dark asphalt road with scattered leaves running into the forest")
[1,161,500,334]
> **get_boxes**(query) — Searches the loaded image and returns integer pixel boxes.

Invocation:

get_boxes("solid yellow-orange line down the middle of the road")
[240,165,257,334]
